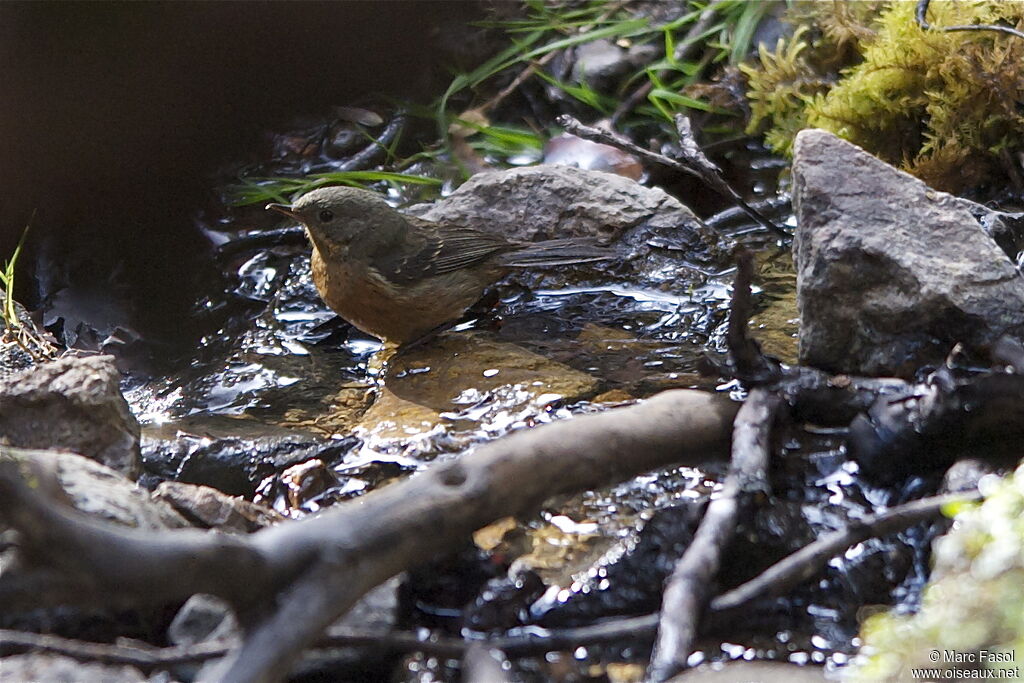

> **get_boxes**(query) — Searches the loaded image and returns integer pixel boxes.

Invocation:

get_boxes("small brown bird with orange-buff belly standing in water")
[267,187,611,344]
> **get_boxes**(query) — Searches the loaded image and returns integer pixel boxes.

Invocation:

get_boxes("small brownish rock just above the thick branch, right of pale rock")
[153,481,285,533]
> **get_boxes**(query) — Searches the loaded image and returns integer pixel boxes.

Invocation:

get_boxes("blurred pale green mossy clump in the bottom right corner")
[849,466,1024,681]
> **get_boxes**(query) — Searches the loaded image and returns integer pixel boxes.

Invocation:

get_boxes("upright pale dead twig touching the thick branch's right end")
[647,389,781,681]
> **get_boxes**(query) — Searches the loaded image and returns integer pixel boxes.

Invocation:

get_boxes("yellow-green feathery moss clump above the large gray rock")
[742,0,1024,191]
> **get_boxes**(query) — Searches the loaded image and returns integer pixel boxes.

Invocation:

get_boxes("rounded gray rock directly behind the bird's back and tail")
[411,166,725,287]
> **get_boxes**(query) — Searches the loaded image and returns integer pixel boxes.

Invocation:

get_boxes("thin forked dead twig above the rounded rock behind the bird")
[555,114,791,239]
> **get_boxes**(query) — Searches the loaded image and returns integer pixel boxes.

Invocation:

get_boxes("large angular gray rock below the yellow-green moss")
[793,130,1024,377]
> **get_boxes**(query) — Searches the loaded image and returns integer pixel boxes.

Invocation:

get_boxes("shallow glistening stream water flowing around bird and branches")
[128,120,938,680]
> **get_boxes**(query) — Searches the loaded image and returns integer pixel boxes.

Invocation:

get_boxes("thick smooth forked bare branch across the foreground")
[0,390,737,683]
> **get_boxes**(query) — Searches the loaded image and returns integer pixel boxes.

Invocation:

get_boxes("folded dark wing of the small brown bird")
[374,219,515,285]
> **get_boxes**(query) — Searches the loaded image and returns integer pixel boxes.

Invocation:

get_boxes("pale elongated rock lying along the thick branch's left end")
[4,449,189,530]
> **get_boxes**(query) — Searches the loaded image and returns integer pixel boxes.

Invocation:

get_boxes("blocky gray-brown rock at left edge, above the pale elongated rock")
[0,356,140,478]
